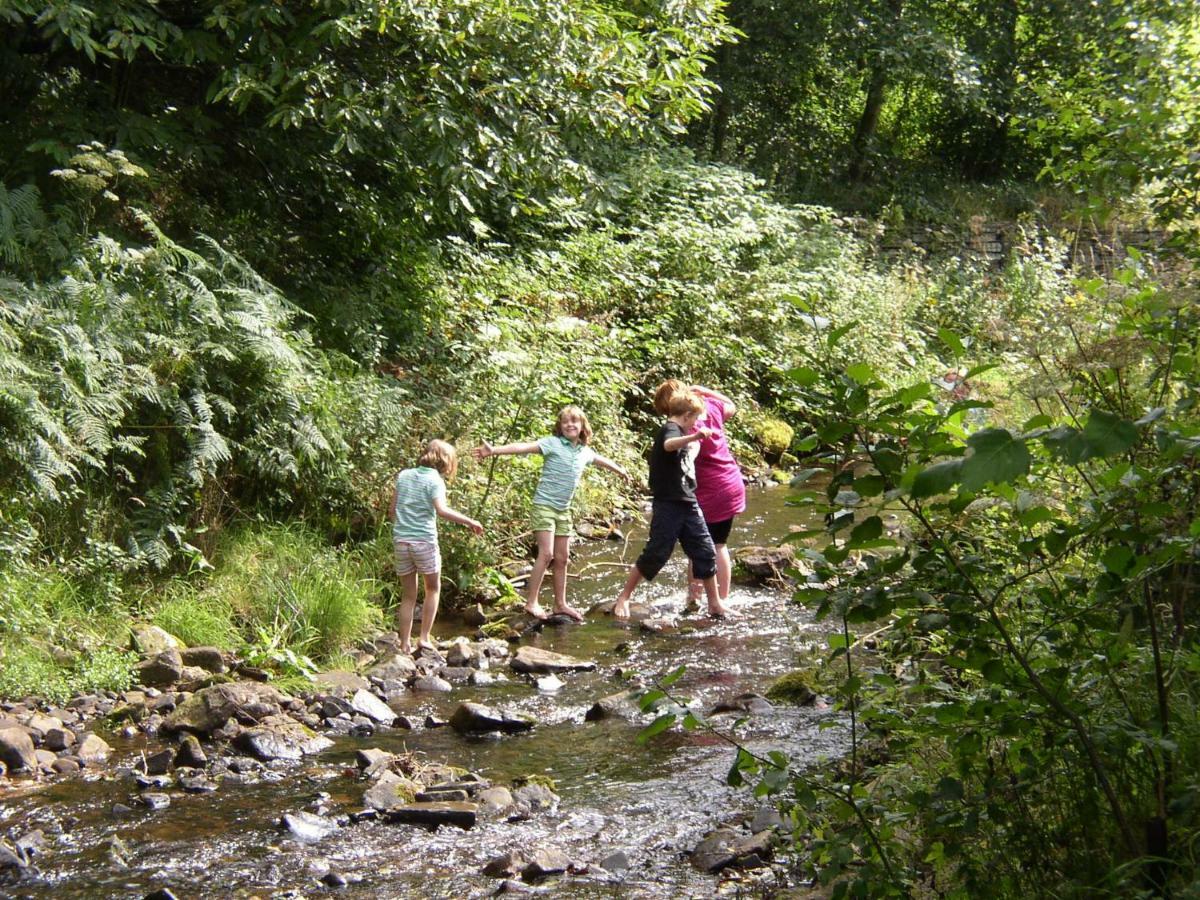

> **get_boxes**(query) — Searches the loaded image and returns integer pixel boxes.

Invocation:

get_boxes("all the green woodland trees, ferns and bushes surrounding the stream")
[0,0,1200,896]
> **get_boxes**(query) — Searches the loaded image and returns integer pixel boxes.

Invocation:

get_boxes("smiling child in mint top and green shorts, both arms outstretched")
[472,406,629,622]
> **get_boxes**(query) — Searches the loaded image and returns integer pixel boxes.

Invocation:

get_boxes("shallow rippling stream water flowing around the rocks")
[0,490,845,898]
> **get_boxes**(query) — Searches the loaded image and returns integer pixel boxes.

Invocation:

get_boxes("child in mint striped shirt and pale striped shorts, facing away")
[391,440,484,653]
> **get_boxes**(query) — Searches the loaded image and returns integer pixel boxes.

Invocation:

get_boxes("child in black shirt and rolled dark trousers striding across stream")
[612,391,727,619]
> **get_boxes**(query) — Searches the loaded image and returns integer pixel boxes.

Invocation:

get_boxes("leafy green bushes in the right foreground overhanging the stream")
[736,250,1200,895]
